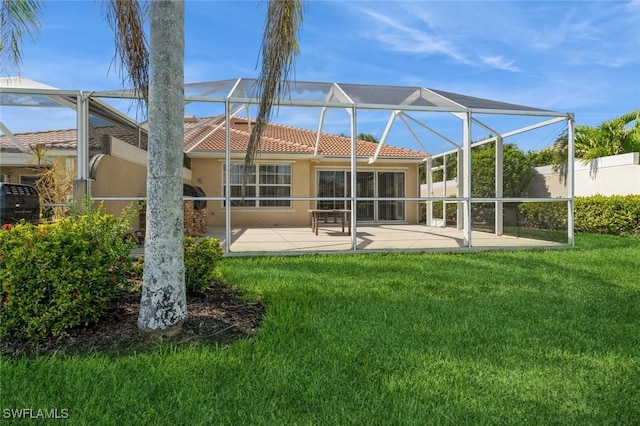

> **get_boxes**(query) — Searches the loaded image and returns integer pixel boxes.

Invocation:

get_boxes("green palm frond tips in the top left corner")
[0,0,42,75]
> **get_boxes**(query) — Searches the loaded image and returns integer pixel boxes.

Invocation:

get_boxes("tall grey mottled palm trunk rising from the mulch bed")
[138,0,187,334]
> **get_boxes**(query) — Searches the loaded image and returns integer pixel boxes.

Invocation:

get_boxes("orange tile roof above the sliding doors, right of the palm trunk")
[185,117,426,158]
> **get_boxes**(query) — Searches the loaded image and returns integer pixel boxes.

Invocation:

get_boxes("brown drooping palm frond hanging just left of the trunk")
[103,0,149,104]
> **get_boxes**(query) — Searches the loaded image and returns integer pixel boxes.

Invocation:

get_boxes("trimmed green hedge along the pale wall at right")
[519,195,640,237]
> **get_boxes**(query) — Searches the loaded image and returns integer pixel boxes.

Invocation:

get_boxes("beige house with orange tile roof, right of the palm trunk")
[185,117,425,227]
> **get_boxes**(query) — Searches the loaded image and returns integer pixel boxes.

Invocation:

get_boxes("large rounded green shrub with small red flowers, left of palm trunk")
[0,205,134,339]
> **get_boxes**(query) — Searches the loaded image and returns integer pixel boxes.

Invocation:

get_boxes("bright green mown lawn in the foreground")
[0,235,640,425]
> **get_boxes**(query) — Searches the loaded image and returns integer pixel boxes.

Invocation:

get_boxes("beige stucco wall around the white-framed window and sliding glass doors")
[191,157,419,228]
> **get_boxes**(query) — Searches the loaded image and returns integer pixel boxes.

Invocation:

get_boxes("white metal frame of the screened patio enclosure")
[0,78,574,254]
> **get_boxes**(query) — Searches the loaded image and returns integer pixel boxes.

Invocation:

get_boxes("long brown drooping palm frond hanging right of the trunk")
[242,0,303,193]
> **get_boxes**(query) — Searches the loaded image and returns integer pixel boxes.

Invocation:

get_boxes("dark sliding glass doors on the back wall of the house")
[317,170,405,222]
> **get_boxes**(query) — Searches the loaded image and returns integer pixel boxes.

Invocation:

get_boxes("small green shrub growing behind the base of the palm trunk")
[134,237,223,294]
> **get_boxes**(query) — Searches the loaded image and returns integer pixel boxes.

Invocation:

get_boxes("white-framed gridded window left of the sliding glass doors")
[223,164,291,207]
